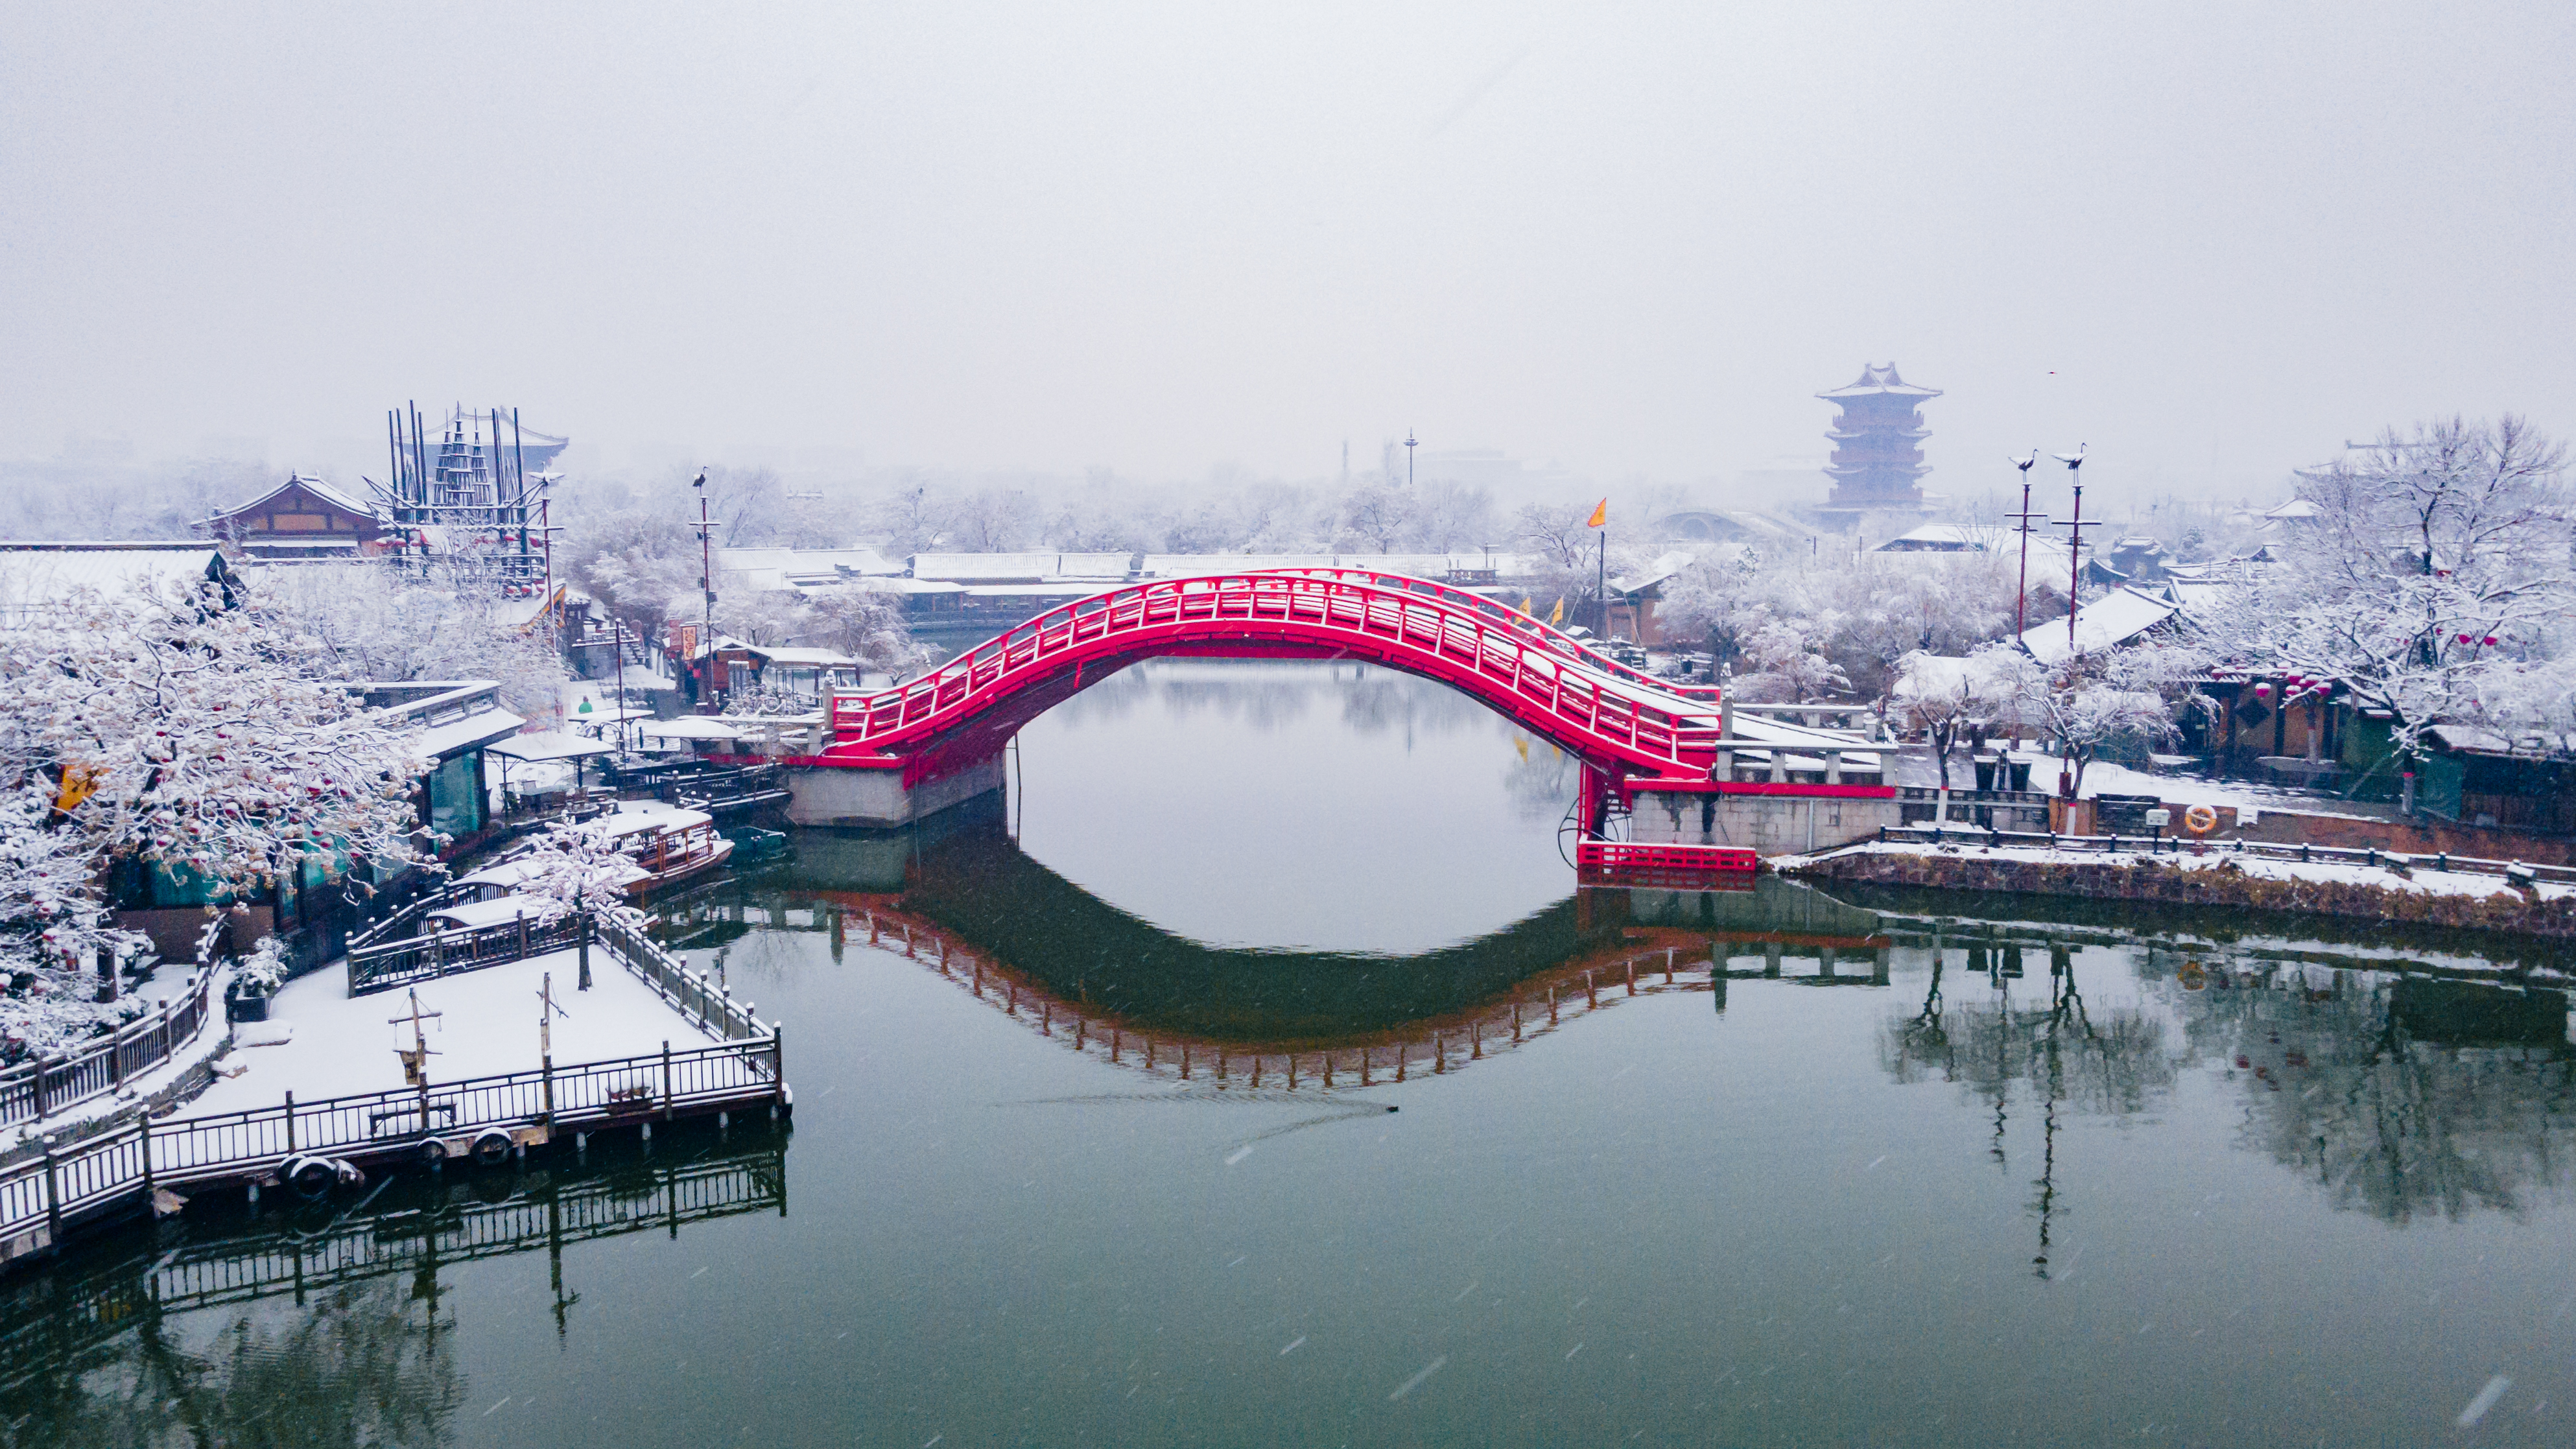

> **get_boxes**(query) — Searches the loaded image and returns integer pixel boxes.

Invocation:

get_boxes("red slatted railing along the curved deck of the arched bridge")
[829,574,1721,770]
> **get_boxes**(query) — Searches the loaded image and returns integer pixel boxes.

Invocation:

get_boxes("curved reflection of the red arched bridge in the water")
[662,816,1891,1091]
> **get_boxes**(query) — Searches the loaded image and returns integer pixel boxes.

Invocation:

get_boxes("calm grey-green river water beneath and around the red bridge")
[0,661,2576,1446]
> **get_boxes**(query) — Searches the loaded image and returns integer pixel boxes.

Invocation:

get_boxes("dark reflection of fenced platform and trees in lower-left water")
[0,1127,786,1444]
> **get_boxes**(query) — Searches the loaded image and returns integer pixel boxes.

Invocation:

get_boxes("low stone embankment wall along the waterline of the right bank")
[1788,849,2576,939]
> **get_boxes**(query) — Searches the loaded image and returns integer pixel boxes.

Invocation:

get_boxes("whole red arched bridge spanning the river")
[794,569,1878,844]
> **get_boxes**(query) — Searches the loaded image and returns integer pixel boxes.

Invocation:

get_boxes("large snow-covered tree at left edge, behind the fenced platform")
[0,576,423,1050]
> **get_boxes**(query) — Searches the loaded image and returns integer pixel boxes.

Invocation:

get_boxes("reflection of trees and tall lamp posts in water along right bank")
[1880,924,2576,1235]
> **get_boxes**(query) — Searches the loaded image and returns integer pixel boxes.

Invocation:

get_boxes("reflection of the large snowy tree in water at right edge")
[2174,958,2576,1223]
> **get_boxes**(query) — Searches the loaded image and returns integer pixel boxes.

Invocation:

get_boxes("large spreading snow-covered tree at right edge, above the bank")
[2216,417,2576,754]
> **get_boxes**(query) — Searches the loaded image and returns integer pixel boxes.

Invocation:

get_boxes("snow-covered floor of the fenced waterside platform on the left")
[180,950,714,1117]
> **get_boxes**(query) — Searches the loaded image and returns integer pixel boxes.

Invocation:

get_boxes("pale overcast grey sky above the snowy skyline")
[0,0,2576,491]
